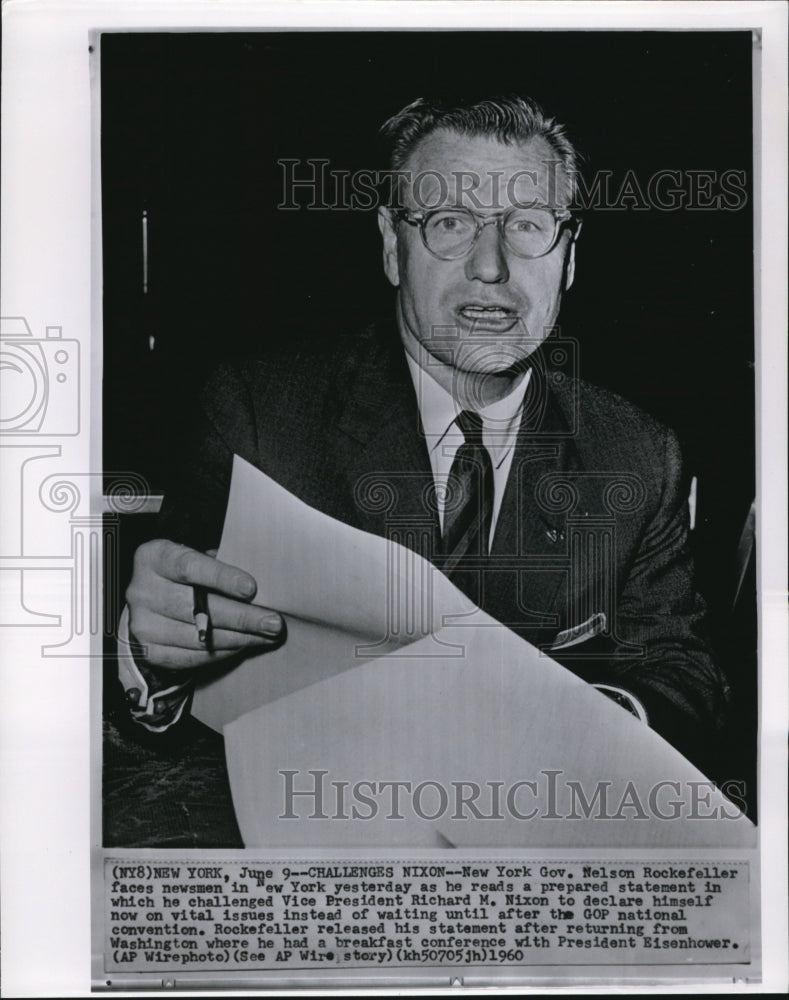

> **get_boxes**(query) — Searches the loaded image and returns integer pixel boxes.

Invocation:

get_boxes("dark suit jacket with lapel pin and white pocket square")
[160,325,728,767]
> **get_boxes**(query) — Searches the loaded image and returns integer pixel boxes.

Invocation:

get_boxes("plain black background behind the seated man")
[101,31,756,812]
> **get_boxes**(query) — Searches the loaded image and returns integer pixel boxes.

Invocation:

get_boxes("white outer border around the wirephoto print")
[0,0,789,996]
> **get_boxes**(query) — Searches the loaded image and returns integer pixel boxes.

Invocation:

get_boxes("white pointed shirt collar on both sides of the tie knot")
[406,351,531,465]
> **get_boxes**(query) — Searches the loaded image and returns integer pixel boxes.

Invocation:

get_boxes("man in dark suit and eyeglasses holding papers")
[121,98,727,765]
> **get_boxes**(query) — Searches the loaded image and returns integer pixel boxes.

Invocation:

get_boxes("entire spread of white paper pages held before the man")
[198,458,754,847]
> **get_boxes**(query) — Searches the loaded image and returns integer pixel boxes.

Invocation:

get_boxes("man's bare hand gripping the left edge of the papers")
[126,539,284,669]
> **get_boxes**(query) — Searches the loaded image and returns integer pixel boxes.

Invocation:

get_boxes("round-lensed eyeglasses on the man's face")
[393,205,573,260]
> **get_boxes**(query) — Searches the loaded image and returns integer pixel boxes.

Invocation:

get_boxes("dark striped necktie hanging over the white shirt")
[442,410,493,575]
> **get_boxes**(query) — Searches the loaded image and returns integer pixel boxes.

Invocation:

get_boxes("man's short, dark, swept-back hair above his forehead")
[380,95,579,176]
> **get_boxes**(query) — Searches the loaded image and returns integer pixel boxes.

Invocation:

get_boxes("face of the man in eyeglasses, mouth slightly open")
[379,130,575,375]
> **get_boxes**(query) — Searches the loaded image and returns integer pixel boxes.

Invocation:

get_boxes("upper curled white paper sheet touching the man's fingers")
[192,455,480,730]
